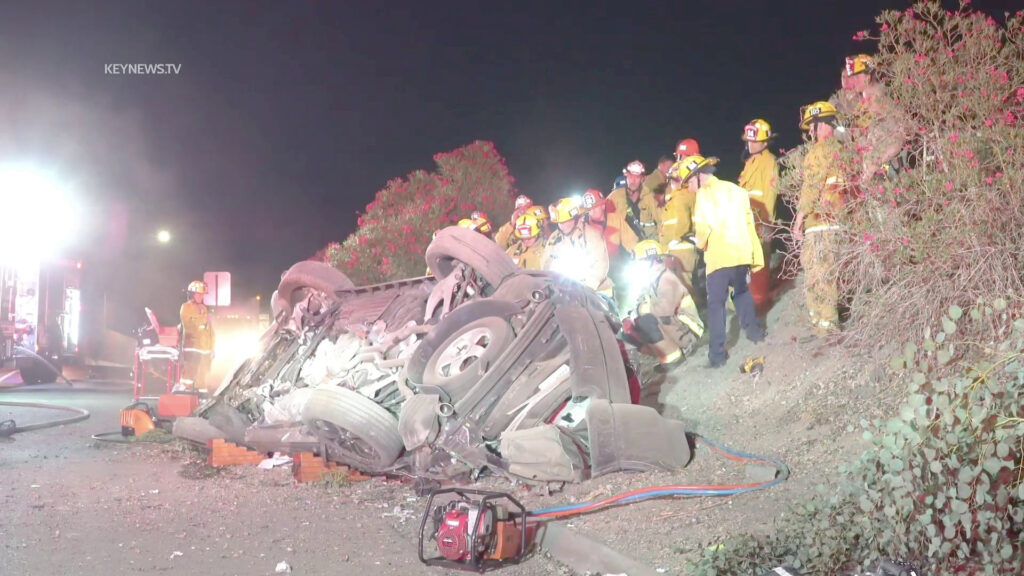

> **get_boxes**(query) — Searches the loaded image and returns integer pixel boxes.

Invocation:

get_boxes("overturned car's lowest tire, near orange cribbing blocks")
[302,386,402,472]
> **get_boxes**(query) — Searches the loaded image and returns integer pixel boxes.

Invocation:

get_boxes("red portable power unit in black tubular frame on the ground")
[419,488,536,573]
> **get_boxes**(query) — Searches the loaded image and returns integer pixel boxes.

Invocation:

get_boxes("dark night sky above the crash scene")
[0,1,1019,327]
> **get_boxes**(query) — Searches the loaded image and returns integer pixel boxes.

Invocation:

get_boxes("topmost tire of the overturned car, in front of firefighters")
[426,227,519,288]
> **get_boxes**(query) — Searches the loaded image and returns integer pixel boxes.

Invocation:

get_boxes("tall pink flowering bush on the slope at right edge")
[780,2,1024,353]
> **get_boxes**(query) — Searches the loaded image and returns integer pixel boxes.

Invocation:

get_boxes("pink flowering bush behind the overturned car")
[314,140,516,285]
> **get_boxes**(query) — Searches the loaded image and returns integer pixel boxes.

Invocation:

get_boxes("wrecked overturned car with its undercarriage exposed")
[197,228,690,482]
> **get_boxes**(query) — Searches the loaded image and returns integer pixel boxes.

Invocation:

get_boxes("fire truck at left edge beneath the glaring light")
[0,260,82,384]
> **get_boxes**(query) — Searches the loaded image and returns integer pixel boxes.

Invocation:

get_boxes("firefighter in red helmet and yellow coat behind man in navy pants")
[658,138,703,297]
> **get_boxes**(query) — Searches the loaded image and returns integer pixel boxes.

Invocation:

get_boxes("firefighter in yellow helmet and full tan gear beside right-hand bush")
[793,101,844,337]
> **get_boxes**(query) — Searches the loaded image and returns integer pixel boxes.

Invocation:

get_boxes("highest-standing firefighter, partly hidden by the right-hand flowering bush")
[841,54,913,181]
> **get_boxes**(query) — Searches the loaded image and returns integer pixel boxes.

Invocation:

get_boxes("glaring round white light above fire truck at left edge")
[0,165,81,263]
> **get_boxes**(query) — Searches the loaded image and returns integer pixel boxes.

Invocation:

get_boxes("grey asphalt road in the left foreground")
[0,373,565,576]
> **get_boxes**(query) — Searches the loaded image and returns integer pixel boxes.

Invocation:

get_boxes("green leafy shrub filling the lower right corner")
[692,300,1024,576]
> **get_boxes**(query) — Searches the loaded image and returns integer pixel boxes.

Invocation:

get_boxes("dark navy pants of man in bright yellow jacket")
[708,266,765,364]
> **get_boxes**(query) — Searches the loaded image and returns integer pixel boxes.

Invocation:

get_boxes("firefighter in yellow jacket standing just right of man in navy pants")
[737,118,778,303]
